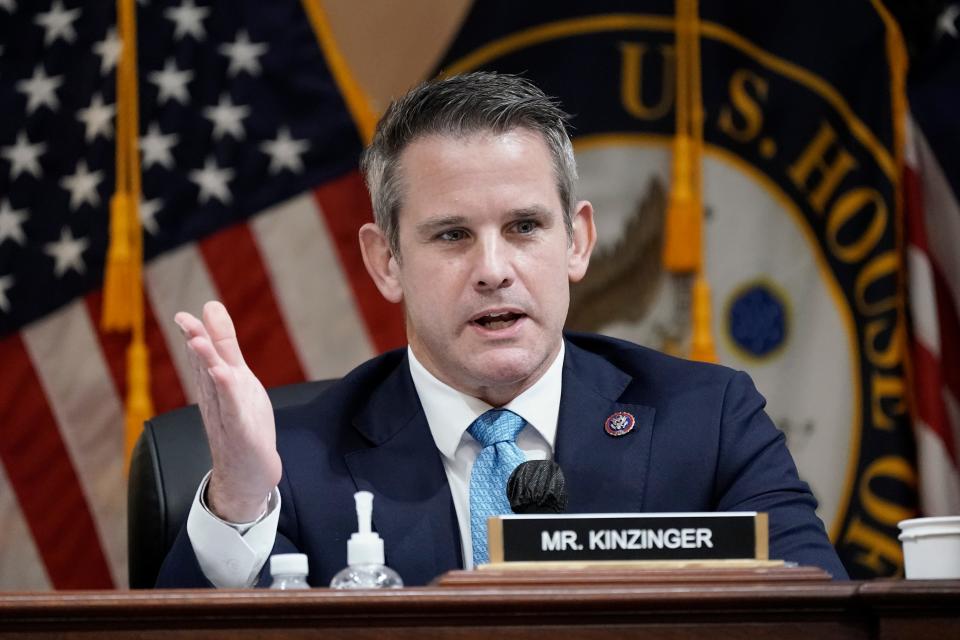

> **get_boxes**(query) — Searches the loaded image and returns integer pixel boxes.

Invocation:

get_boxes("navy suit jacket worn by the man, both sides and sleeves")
[157,334,846,587]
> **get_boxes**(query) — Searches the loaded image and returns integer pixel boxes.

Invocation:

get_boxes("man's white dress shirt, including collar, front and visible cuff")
[187,341,564,588]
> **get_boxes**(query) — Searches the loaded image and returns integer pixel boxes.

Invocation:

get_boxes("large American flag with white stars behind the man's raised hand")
[0,0,403,589]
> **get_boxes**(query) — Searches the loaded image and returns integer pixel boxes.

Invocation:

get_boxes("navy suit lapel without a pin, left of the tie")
[344,358,463,584]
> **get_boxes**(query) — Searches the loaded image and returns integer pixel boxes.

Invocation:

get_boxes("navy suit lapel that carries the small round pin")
[554,341,655,513]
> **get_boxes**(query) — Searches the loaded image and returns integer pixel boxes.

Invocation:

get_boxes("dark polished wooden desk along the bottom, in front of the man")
[0,577,960,640]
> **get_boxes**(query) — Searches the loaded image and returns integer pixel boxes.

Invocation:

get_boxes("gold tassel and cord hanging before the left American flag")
[101,0,153,463]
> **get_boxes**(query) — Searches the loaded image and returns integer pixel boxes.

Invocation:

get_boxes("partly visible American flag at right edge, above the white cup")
[905,2,960,516]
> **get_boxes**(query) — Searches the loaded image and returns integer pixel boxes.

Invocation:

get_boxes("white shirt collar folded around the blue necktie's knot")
[407,340,566,459]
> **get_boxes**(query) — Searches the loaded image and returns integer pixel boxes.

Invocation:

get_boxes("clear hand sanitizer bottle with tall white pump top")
[330,491,403,589]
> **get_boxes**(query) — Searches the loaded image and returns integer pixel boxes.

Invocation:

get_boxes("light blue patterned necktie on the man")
[467,409,527,566]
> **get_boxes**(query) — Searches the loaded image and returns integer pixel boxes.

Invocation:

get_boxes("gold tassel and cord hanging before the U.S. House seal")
[663,0,717,362]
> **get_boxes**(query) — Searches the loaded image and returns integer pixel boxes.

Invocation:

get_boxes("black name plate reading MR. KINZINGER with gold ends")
[487,512,769,564]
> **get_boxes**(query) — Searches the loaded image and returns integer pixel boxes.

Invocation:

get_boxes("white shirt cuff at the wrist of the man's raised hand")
[187,473,280,588]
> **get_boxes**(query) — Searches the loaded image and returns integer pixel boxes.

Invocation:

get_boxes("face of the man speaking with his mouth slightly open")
[368,129,595,405]
